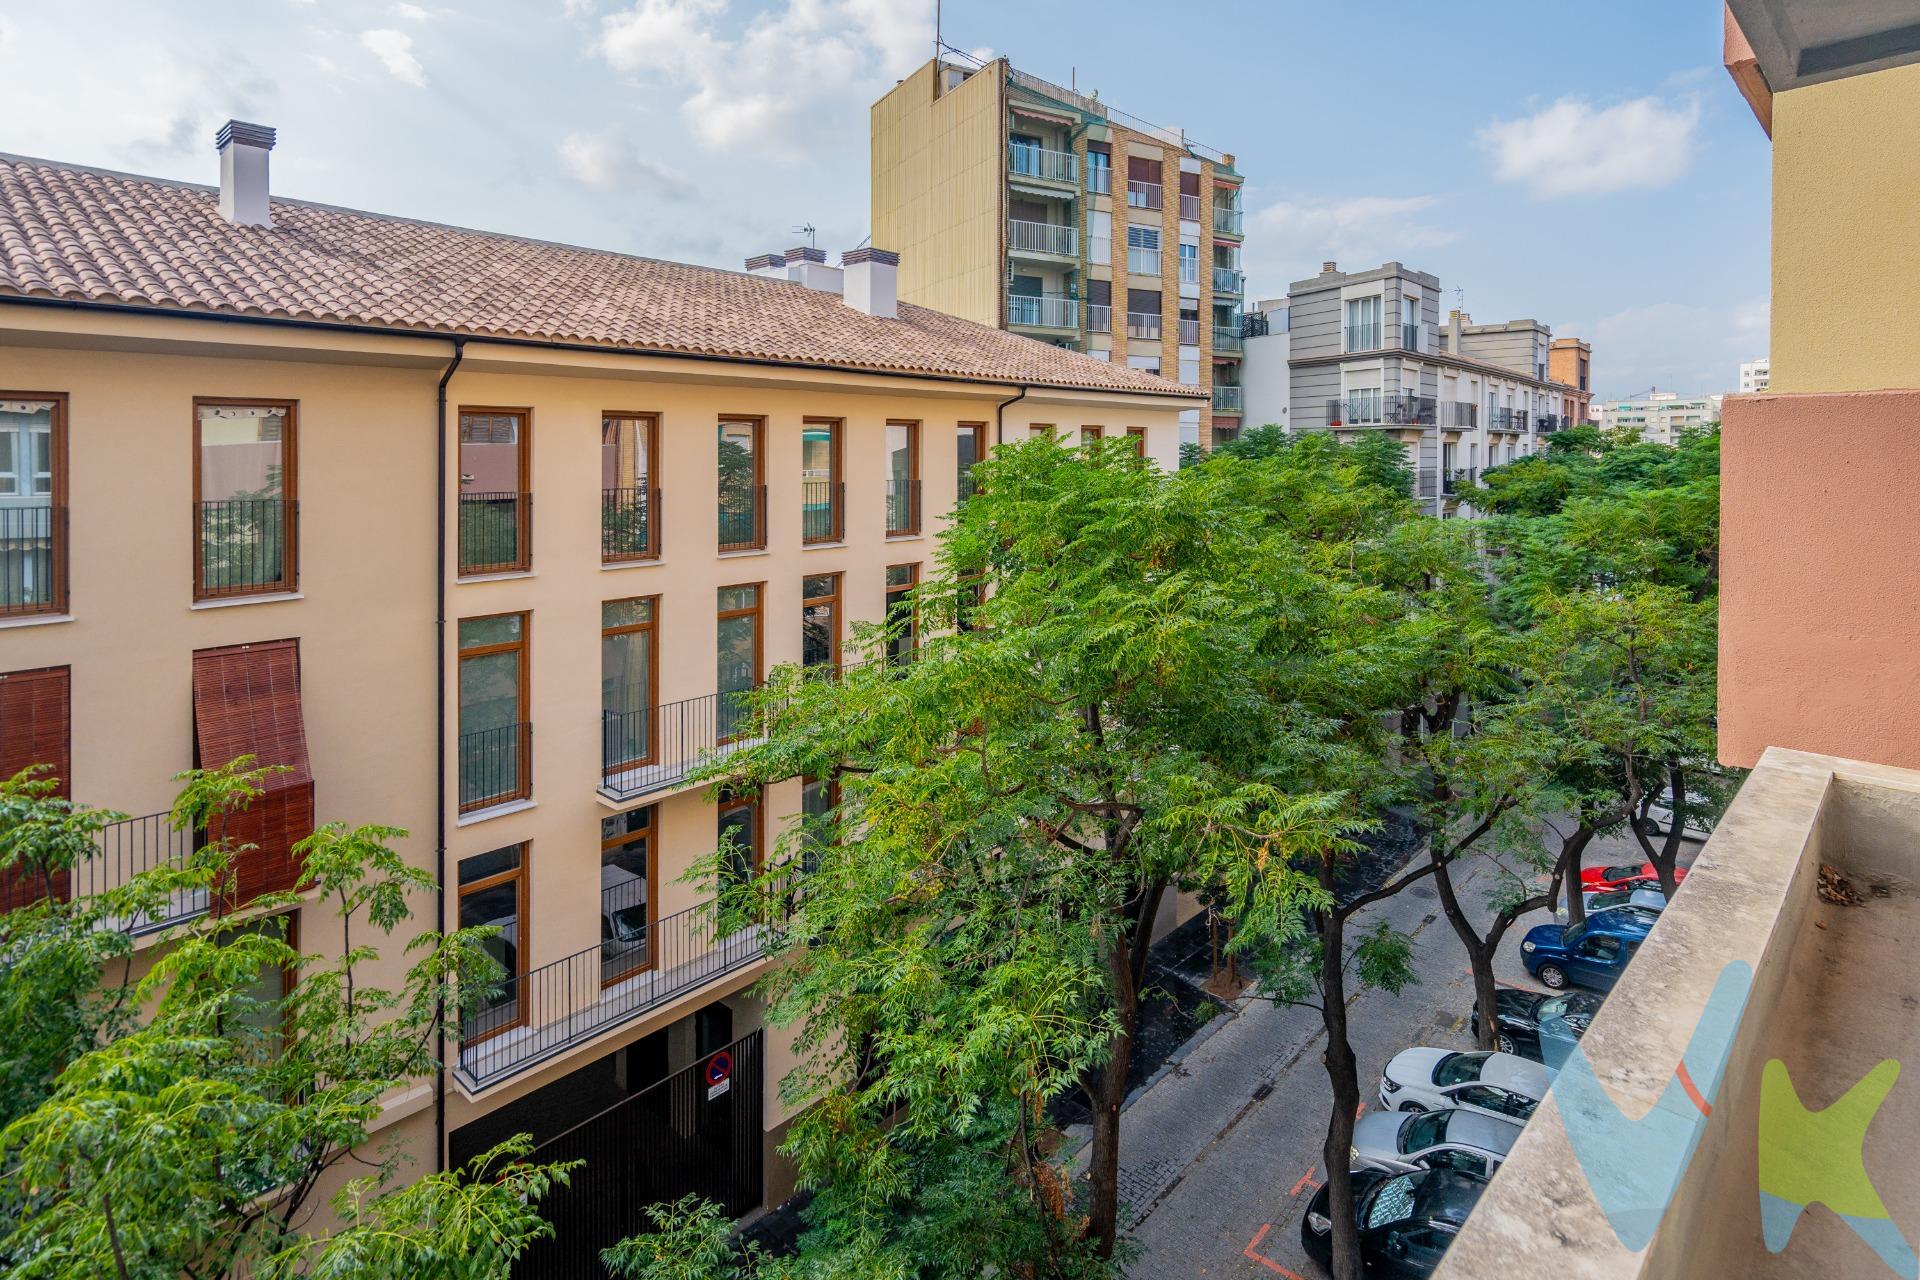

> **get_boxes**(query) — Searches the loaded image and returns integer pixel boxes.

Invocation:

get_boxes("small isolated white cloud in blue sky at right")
[1480,98,1699,200]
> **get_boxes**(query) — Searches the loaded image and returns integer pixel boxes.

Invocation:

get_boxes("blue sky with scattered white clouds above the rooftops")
[0,0,1770,399]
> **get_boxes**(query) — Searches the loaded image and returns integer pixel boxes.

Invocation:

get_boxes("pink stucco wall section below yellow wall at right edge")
[1720,391,1920,768]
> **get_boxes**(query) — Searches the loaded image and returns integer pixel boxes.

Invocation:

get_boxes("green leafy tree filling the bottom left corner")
[0,758,566,1280]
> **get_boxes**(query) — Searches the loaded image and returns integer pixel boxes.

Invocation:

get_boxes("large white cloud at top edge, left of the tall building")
[595,0,933,154]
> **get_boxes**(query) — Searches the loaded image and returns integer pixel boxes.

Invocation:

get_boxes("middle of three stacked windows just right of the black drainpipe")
[459,614,534,814]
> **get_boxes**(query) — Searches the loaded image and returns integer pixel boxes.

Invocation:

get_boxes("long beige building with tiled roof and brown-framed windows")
[0,123,1200,1276]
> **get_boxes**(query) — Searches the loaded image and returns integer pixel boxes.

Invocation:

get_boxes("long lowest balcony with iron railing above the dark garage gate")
[459,900,780,1088]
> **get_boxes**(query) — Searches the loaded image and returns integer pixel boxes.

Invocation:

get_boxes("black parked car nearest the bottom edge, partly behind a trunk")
[1300,1169,1486,1280]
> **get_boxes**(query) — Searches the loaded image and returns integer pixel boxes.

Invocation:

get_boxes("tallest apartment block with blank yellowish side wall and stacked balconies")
[872,52,1246,454]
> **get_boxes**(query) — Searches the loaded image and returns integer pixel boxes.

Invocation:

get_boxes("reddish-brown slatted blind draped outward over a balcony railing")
[194,641,313,912]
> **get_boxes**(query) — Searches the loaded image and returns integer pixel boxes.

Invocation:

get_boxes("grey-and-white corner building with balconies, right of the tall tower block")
[1274,263,1580,516]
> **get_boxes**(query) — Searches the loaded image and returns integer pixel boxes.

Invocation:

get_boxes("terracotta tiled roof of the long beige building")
[0,155,1200,397]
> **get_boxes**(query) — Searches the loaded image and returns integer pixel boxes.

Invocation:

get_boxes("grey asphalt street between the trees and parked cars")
[1121,825,1697,1280]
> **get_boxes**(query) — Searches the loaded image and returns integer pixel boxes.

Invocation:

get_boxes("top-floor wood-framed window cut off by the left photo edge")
[0,391,67,618]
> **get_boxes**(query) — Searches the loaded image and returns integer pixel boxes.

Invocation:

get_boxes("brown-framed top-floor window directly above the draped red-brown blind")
[194,399,298,601]
